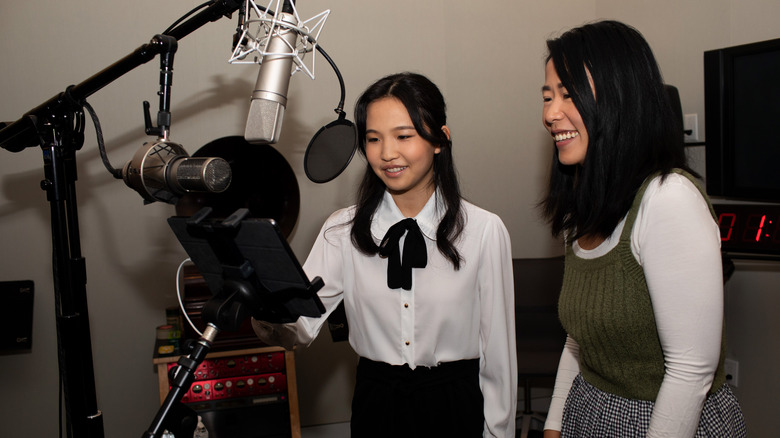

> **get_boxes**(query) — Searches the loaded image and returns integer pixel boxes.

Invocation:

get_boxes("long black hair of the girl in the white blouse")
[351,72,464,269]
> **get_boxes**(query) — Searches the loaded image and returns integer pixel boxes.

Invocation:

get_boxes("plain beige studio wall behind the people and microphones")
[0,0,780,437]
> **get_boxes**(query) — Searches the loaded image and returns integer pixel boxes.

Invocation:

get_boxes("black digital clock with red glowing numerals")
[713,204,780,255]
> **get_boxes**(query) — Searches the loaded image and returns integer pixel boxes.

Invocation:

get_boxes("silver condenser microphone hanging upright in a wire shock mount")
[244,0,300,144]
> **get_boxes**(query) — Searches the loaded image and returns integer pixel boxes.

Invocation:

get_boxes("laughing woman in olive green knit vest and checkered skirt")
[541,21,745,438]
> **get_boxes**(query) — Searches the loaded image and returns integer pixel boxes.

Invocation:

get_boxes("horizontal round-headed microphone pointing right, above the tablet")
[122,140,232,204]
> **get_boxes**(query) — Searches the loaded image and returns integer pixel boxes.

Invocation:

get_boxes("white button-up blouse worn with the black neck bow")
[296,193,517,437]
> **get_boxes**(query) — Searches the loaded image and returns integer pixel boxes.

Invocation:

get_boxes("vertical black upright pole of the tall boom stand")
[41,112,103,438]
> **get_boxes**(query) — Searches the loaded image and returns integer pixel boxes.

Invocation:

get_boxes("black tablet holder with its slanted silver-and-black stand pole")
[142,207,325,438]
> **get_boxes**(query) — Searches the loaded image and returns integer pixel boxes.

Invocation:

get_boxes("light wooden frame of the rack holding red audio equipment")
[152,347,301,438]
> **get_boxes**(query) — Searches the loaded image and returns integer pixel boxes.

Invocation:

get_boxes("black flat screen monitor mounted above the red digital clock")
[704,39,780,202]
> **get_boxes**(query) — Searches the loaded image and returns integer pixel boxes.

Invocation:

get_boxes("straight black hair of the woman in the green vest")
[540,21,693,240]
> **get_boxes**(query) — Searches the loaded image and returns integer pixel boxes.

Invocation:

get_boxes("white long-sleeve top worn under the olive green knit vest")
[545,173,723,438]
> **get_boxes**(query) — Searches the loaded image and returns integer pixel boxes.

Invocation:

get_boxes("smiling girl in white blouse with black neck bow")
[255,73,517,438]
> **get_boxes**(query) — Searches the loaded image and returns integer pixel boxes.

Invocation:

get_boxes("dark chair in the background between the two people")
[512,256,566,438]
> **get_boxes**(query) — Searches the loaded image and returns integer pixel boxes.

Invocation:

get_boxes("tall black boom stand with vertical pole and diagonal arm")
[0,0,242,438]
